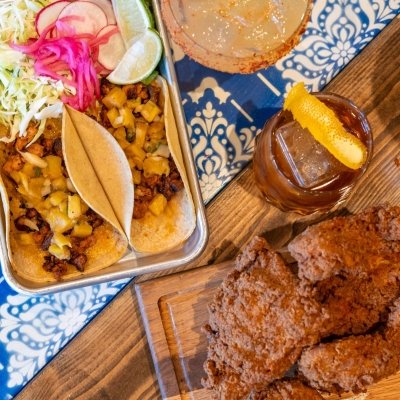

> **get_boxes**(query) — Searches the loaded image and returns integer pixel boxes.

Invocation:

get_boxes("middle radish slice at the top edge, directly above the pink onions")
[58,1,107,35]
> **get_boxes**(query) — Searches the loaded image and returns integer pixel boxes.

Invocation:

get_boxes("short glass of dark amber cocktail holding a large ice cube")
[253,93,373,214]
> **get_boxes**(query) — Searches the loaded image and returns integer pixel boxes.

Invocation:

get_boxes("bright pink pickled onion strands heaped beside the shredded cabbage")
[12,16,118,111]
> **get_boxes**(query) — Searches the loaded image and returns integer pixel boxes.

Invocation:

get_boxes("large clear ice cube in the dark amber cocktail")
[276,121,348,189]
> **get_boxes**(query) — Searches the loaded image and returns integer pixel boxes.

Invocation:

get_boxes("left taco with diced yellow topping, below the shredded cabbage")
[0,119,128,282]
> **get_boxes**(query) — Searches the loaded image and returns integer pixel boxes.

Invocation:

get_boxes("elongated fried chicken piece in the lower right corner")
[299,299,400,394]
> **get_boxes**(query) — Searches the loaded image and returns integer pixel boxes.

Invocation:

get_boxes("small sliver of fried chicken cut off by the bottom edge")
[249,379,323,400]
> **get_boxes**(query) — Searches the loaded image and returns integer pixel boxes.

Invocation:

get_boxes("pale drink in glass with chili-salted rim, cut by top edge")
[161,0,312,73]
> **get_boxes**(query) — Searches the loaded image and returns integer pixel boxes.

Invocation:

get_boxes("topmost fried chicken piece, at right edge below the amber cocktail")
[288,206,400,282]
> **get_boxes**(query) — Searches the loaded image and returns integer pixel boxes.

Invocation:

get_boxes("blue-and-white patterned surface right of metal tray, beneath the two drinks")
[174,0,400,202]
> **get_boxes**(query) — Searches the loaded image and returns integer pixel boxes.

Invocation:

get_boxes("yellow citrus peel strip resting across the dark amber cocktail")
[283,82,367,169]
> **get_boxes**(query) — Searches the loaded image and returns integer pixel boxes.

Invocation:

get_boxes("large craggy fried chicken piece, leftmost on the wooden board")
[203,237,324,400]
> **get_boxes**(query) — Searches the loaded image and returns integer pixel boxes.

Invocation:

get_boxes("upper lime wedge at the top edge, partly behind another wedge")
[112,0,154,48]
